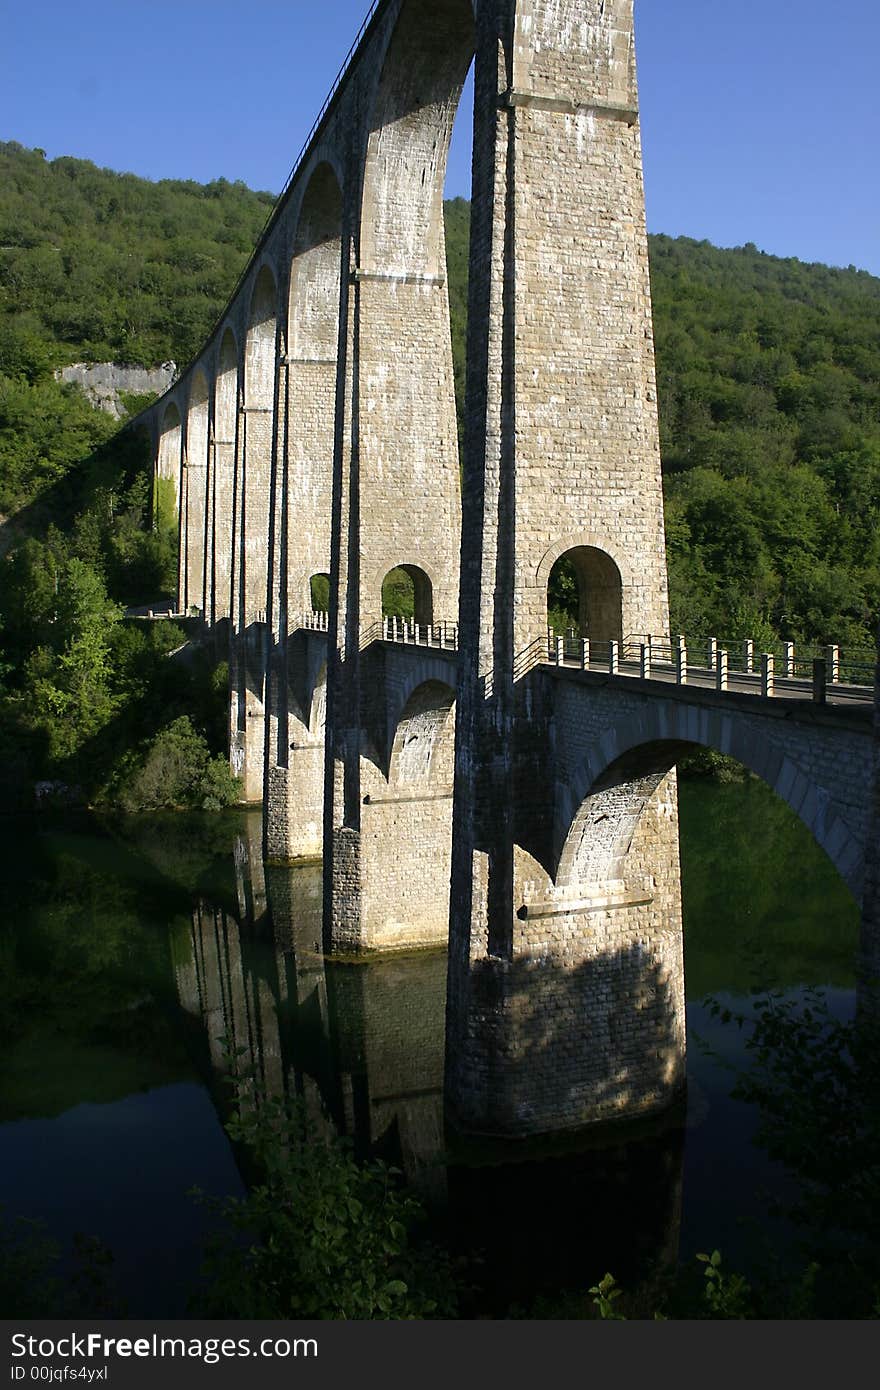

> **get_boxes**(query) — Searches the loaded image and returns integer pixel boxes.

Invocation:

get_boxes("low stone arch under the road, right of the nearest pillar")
[556,701,863,899]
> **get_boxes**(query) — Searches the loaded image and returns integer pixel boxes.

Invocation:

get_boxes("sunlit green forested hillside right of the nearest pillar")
[651,236,880,646]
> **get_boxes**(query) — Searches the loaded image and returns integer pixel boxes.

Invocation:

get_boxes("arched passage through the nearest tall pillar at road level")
[546,545,623,642]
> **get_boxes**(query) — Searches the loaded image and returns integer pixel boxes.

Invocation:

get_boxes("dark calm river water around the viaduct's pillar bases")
[0,778,858,1318]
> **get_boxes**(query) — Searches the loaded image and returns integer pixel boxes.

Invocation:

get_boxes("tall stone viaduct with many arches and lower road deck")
[137,0,876,1134]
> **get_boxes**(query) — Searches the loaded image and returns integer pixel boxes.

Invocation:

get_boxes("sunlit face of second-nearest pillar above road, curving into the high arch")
[353,0,474,636]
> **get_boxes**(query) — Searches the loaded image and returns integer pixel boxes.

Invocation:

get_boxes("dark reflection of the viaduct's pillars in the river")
[169,820,683,1312]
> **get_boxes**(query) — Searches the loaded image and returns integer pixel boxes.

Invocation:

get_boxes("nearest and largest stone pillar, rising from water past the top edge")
[446,0,684,1134]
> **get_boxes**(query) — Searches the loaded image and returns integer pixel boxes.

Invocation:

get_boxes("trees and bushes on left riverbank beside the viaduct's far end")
[0,436,238,810]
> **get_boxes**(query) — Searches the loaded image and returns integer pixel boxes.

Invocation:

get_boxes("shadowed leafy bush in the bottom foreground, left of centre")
[196,1099,456,1319]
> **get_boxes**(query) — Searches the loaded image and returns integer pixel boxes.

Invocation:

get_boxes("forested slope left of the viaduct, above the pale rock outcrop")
[0,143,274,373]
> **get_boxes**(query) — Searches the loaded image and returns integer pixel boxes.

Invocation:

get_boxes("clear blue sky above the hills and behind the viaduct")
[0,0,880,274]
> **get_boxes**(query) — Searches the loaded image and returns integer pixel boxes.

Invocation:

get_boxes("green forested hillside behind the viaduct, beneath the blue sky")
[0,143,880,648]
